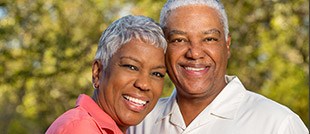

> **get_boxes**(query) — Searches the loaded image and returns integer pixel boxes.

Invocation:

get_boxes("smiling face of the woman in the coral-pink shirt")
[93,39,166,131]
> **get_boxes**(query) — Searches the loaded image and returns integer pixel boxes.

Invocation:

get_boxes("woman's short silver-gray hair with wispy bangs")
[95,15,167,70]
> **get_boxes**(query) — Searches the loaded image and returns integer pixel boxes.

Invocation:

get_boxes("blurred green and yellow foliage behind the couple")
[0,0,309,134]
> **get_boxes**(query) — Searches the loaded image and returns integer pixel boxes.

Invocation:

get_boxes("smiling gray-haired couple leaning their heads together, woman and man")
[46,0,309,134]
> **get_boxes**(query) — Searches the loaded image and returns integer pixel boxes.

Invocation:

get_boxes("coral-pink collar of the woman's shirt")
[76,94,122,134]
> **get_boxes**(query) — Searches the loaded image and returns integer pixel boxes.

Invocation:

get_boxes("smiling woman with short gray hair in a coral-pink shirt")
[46,15,167,134]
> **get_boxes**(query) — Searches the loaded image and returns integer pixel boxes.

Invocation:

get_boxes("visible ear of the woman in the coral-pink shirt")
[92,60,103,89]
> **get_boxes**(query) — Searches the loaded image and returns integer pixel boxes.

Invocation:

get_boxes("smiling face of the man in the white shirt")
[164,6,230,98]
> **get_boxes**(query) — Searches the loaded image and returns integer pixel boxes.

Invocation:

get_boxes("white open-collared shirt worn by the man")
[127,76,309,134]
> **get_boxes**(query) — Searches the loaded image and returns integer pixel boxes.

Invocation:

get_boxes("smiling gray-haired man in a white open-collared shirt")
[128,0,309,134]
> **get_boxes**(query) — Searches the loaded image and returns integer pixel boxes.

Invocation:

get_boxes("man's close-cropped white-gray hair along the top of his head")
[160,0,229,40]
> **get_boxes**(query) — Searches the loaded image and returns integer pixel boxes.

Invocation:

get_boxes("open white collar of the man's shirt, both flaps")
[156,76,246,123]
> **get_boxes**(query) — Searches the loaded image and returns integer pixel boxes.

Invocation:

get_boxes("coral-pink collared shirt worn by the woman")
[46,94,122,134]
